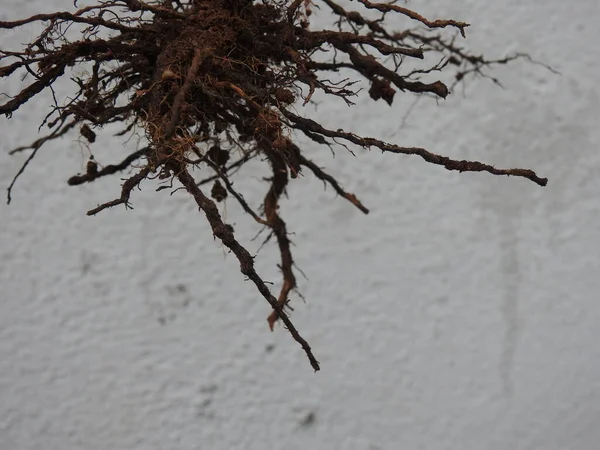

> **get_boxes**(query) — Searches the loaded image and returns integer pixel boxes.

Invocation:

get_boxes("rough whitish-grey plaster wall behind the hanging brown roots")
[0,0,600,450]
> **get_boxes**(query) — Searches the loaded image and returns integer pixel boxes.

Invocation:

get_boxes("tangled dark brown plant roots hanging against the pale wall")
[0,0,547,370]
